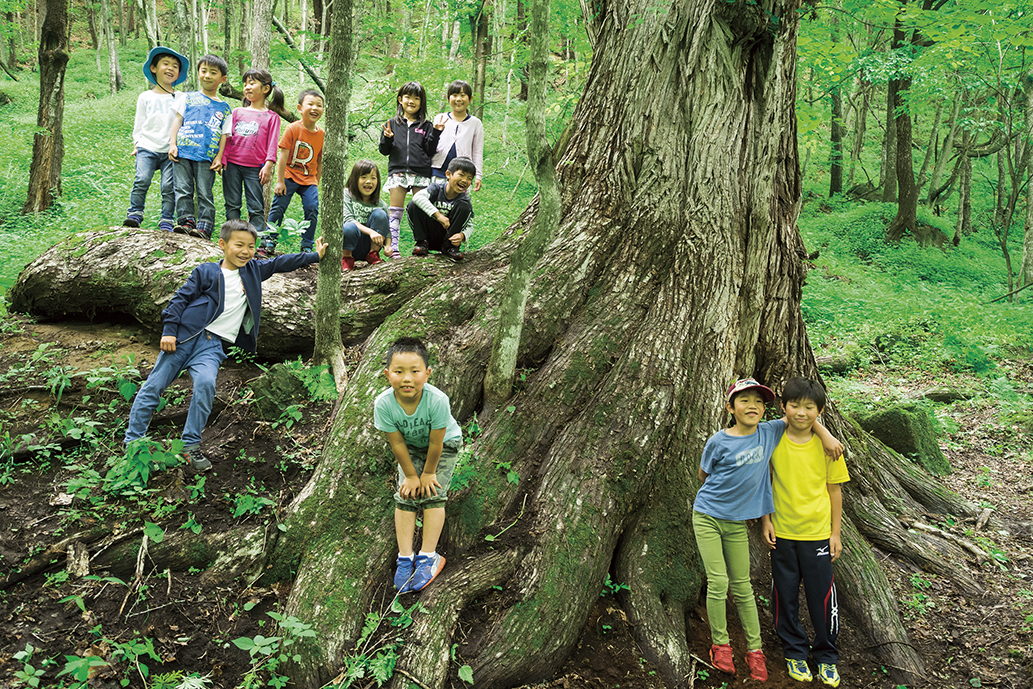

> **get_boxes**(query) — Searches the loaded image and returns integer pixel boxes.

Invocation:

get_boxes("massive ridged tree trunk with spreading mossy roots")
[11,0,978,689]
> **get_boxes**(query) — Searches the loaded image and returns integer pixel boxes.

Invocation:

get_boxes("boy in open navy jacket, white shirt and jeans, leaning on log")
[125,220,326,471]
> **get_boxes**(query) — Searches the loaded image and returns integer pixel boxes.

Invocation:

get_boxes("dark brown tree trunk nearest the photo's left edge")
[22,0,68,213]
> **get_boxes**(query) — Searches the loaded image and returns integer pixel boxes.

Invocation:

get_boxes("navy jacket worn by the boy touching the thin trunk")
[161,251,319,352]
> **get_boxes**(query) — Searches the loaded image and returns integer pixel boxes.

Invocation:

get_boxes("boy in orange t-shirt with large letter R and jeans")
[258,89,323,258]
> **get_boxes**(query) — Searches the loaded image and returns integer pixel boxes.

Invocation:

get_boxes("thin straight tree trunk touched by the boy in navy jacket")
[313,0,355,392]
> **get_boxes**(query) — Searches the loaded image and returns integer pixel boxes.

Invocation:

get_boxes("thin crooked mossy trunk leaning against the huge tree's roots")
[482,0,560,419]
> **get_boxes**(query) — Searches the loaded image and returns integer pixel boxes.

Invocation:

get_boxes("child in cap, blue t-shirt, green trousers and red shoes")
[692,378,843,682]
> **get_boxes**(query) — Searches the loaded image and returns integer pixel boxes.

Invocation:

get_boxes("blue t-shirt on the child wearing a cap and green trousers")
[692,419,785,522]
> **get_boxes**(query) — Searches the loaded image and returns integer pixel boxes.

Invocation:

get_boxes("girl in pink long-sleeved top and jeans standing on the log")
[222,68,283,234]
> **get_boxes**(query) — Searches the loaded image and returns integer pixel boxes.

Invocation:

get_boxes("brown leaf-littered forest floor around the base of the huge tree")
[0,318,1033,689]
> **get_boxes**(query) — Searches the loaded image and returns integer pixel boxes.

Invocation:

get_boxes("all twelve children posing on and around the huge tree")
[125,41,849,687]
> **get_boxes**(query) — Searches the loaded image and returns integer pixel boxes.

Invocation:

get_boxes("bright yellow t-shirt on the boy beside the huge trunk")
[772,434,850,540]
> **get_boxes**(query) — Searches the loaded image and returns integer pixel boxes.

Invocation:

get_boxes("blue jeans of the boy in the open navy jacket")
[125,331,226,449]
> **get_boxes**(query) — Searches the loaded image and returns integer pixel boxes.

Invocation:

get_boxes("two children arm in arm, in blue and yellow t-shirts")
[692,378,850,687]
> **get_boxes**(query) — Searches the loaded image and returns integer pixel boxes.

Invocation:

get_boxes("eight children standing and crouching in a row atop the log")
[124,45,484,271]
